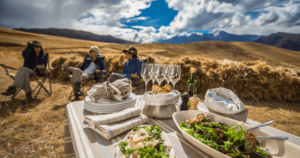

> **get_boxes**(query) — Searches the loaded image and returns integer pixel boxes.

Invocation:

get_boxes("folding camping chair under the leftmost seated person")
[0,53,52,100]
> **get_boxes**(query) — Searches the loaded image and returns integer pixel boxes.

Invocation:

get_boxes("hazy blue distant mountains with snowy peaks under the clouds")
[160,31,262,44]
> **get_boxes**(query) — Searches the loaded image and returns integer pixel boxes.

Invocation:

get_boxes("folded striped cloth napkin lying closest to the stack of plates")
[84,108,142,128]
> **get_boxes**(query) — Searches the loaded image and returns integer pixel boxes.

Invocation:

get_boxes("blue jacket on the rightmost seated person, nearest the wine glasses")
[122,58,143,78]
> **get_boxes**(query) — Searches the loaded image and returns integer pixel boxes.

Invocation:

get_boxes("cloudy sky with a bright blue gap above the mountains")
[0,0,300,43]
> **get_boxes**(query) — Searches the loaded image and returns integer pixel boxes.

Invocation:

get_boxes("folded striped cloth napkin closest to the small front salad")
[88,115,149,139]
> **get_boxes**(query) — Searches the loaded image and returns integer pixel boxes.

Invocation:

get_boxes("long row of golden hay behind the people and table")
[52,54,300,102]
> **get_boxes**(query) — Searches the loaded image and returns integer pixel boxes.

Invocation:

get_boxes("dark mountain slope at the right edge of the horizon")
[254,32,300,51]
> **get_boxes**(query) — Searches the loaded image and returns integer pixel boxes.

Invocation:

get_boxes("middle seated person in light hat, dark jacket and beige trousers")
[70,46,105,100]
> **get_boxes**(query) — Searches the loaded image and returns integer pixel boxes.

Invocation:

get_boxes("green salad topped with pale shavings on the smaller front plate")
[116,125,172,158]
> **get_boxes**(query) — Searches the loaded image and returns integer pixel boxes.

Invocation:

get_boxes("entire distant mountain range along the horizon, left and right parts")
[14,28,300,51]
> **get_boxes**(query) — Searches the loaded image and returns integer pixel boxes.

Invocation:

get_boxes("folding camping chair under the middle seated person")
[61,56,108,100]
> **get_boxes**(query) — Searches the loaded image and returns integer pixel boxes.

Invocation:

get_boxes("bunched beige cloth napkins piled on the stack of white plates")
[87,75,132,103]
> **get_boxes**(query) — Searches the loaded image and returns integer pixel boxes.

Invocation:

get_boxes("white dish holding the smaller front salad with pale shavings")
[115,125,175,158]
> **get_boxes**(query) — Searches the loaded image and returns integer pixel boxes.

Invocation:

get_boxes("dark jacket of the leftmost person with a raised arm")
[22,44,48,74]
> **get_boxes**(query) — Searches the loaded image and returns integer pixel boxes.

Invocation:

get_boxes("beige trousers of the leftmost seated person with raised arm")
[12,67,34,93]
